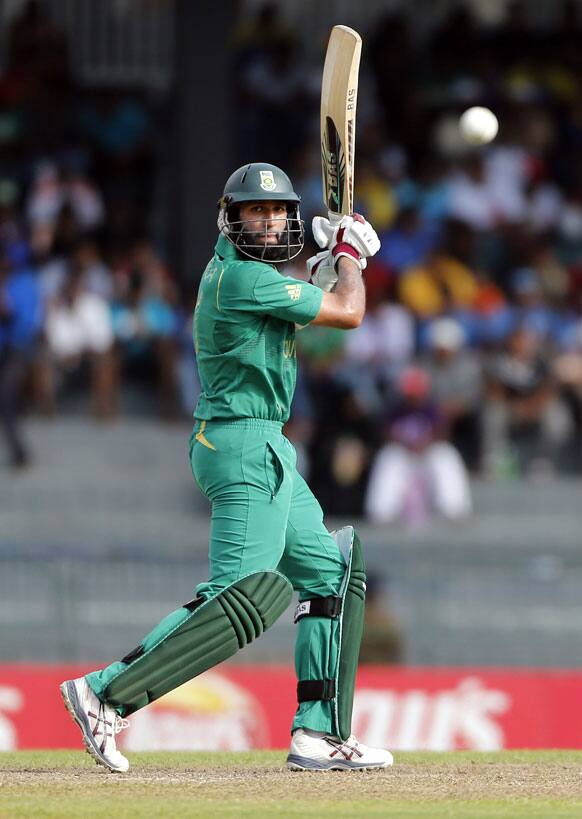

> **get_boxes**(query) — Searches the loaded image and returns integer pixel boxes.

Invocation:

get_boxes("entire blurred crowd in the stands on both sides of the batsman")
[0,2,582,532]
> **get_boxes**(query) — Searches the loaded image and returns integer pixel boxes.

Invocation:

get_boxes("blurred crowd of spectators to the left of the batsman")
[0,0,189,468]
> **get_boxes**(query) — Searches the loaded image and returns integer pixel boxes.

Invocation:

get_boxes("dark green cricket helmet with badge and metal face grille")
[218,162,305,264]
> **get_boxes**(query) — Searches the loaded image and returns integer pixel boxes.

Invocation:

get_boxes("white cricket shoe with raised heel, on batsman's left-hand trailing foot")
[60,677,129,772]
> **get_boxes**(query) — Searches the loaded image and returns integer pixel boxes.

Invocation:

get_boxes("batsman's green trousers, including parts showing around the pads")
[87,419,346,732]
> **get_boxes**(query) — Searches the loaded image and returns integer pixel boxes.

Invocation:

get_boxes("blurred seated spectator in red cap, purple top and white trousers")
[365,367,471,523]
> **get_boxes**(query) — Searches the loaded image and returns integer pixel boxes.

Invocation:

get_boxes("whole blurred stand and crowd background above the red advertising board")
[0,0,582,752]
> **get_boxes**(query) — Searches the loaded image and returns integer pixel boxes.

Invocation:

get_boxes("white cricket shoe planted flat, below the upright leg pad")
[287,728,394,771]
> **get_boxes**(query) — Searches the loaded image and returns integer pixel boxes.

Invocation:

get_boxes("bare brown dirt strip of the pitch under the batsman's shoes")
[0,762,582,801]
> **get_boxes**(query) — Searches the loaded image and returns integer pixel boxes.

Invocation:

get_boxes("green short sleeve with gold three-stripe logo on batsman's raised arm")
[219,263,323,324]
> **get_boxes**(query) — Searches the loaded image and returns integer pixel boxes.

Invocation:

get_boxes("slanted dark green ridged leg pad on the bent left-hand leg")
[101,571,293,714]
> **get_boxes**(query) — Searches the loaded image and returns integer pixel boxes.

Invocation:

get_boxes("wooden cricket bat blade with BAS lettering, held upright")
[321,26,362,222]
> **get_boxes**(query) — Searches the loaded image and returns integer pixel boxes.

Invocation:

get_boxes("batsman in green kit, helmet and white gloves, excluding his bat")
[61,162,392,771]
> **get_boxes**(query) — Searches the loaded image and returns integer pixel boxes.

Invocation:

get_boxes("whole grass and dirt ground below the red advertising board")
[0,751,582,819]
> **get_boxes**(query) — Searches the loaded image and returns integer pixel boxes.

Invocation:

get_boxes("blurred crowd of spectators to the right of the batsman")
[235,2,582,521]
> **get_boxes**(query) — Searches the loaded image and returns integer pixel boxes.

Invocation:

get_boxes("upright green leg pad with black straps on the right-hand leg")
[295,526,366,741]
